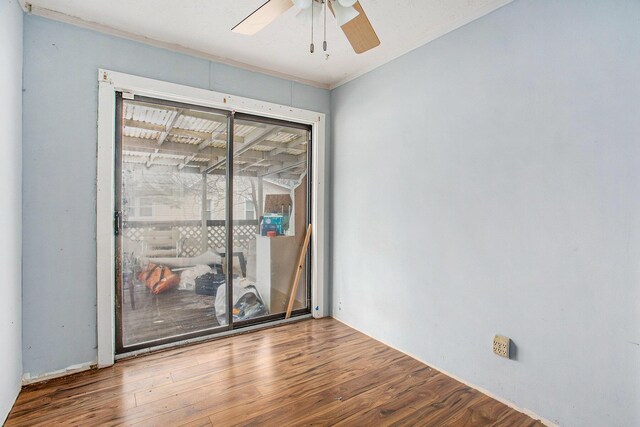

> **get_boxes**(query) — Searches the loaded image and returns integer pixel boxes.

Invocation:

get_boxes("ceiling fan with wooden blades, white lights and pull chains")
[231,0,380,53]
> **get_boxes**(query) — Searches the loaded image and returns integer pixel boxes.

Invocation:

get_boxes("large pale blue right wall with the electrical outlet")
[330,0,640,427]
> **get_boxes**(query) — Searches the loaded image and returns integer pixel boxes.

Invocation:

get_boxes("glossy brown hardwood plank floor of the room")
[6,318,542,426]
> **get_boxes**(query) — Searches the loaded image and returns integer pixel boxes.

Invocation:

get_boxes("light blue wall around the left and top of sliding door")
[23,16,330,376]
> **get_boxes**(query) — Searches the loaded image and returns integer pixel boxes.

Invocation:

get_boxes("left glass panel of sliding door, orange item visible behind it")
[116,97,228,352]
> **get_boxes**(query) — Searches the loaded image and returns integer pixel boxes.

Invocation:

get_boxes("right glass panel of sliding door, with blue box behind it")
[232,114,310,326]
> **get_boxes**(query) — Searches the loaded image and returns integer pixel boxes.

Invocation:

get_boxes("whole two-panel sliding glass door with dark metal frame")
[114,95,311,353]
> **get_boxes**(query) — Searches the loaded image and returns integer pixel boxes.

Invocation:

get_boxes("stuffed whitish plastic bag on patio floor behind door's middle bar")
[216,279,269,326]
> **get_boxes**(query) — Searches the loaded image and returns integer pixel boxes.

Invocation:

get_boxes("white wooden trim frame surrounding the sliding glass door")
[96,69,325,367]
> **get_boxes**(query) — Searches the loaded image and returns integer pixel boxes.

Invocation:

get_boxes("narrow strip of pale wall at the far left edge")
[0,0,23,423]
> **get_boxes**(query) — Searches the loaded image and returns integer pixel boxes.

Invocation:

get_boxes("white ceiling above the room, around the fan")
[28,0,512,88]
